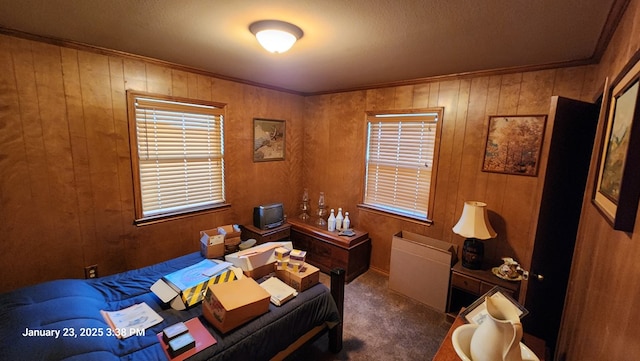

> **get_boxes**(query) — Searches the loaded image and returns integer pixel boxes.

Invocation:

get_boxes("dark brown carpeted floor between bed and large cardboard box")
[292,270,451,361]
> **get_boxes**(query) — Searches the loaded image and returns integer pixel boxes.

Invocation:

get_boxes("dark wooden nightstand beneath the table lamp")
[447,262,520,319]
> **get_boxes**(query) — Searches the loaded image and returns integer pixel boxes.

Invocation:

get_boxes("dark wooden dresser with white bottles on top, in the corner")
[287,218,371,282]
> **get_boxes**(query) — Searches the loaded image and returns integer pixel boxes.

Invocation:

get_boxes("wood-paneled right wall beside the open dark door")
[557,0,640,361]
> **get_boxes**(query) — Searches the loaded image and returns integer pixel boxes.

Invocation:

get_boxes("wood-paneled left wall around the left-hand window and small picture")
[0,35,303,292]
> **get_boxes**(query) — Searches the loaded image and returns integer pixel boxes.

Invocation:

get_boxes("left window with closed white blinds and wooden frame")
[127,92,225,223]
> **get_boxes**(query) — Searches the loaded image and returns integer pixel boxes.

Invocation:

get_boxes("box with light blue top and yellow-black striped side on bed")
[151,259,242,310]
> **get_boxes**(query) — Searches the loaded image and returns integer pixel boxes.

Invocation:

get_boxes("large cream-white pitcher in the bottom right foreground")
[470,297,522,361]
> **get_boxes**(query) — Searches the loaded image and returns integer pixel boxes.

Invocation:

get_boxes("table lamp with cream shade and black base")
[453,201,497,269]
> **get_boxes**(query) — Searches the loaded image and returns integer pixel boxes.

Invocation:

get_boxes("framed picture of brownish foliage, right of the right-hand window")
[482,115,547,177]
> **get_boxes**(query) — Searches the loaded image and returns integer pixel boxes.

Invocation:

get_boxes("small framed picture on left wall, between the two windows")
[253,118,286,162]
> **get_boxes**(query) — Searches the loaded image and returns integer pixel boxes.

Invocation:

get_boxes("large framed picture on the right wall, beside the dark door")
[593,56,640,232]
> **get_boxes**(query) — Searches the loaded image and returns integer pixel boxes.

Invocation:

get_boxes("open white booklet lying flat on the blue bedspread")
[100,302,163,339]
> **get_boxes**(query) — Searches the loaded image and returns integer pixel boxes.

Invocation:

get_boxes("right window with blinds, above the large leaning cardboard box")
[364,109,442,221]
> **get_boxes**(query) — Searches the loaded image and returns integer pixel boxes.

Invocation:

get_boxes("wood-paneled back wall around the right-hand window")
[302,67,593,278]
